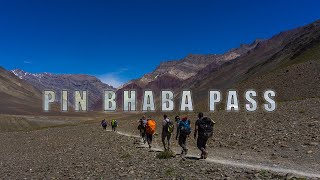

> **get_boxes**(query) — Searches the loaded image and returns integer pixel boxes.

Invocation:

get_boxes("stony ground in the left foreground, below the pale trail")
[0,121,316,179]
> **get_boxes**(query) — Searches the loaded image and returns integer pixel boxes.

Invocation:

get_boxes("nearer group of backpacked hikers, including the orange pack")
[138,112,215,159]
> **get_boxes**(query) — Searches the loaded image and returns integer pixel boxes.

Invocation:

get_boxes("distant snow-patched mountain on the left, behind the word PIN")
[12,69,114,110]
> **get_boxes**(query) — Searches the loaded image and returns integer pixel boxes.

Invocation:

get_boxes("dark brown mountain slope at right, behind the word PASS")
[185,21,320,109]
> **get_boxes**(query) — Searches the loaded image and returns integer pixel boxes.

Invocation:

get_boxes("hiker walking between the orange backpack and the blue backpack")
[161,114,174,151]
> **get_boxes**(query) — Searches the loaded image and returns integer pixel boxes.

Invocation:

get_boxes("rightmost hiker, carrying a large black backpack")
[194,112,215,159]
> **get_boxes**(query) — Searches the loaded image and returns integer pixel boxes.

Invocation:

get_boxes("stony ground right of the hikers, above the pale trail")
[113,98,320,179]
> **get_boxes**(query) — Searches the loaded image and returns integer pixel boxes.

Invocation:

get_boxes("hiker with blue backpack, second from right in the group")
[176,117,191,155]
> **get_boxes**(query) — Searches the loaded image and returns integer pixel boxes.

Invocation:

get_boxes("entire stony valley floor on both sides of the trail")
[0,95,320,179]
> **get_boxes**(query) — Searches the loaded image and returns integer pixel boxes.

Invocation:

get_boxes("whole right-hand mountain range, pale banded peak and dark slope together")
[118,21,320,110]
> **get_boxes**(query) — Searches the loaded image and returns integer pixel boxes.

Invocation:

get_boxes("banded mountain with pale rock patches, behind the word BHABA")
[114,40,264,110]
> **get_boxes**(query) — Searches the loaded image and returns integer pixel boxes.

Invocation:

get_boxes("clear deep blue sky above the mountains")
[0,0,320,87]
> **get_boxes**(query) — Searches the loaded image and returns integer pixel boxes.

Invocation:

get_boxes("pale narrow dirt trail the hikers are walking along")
[117,131,320,178]
